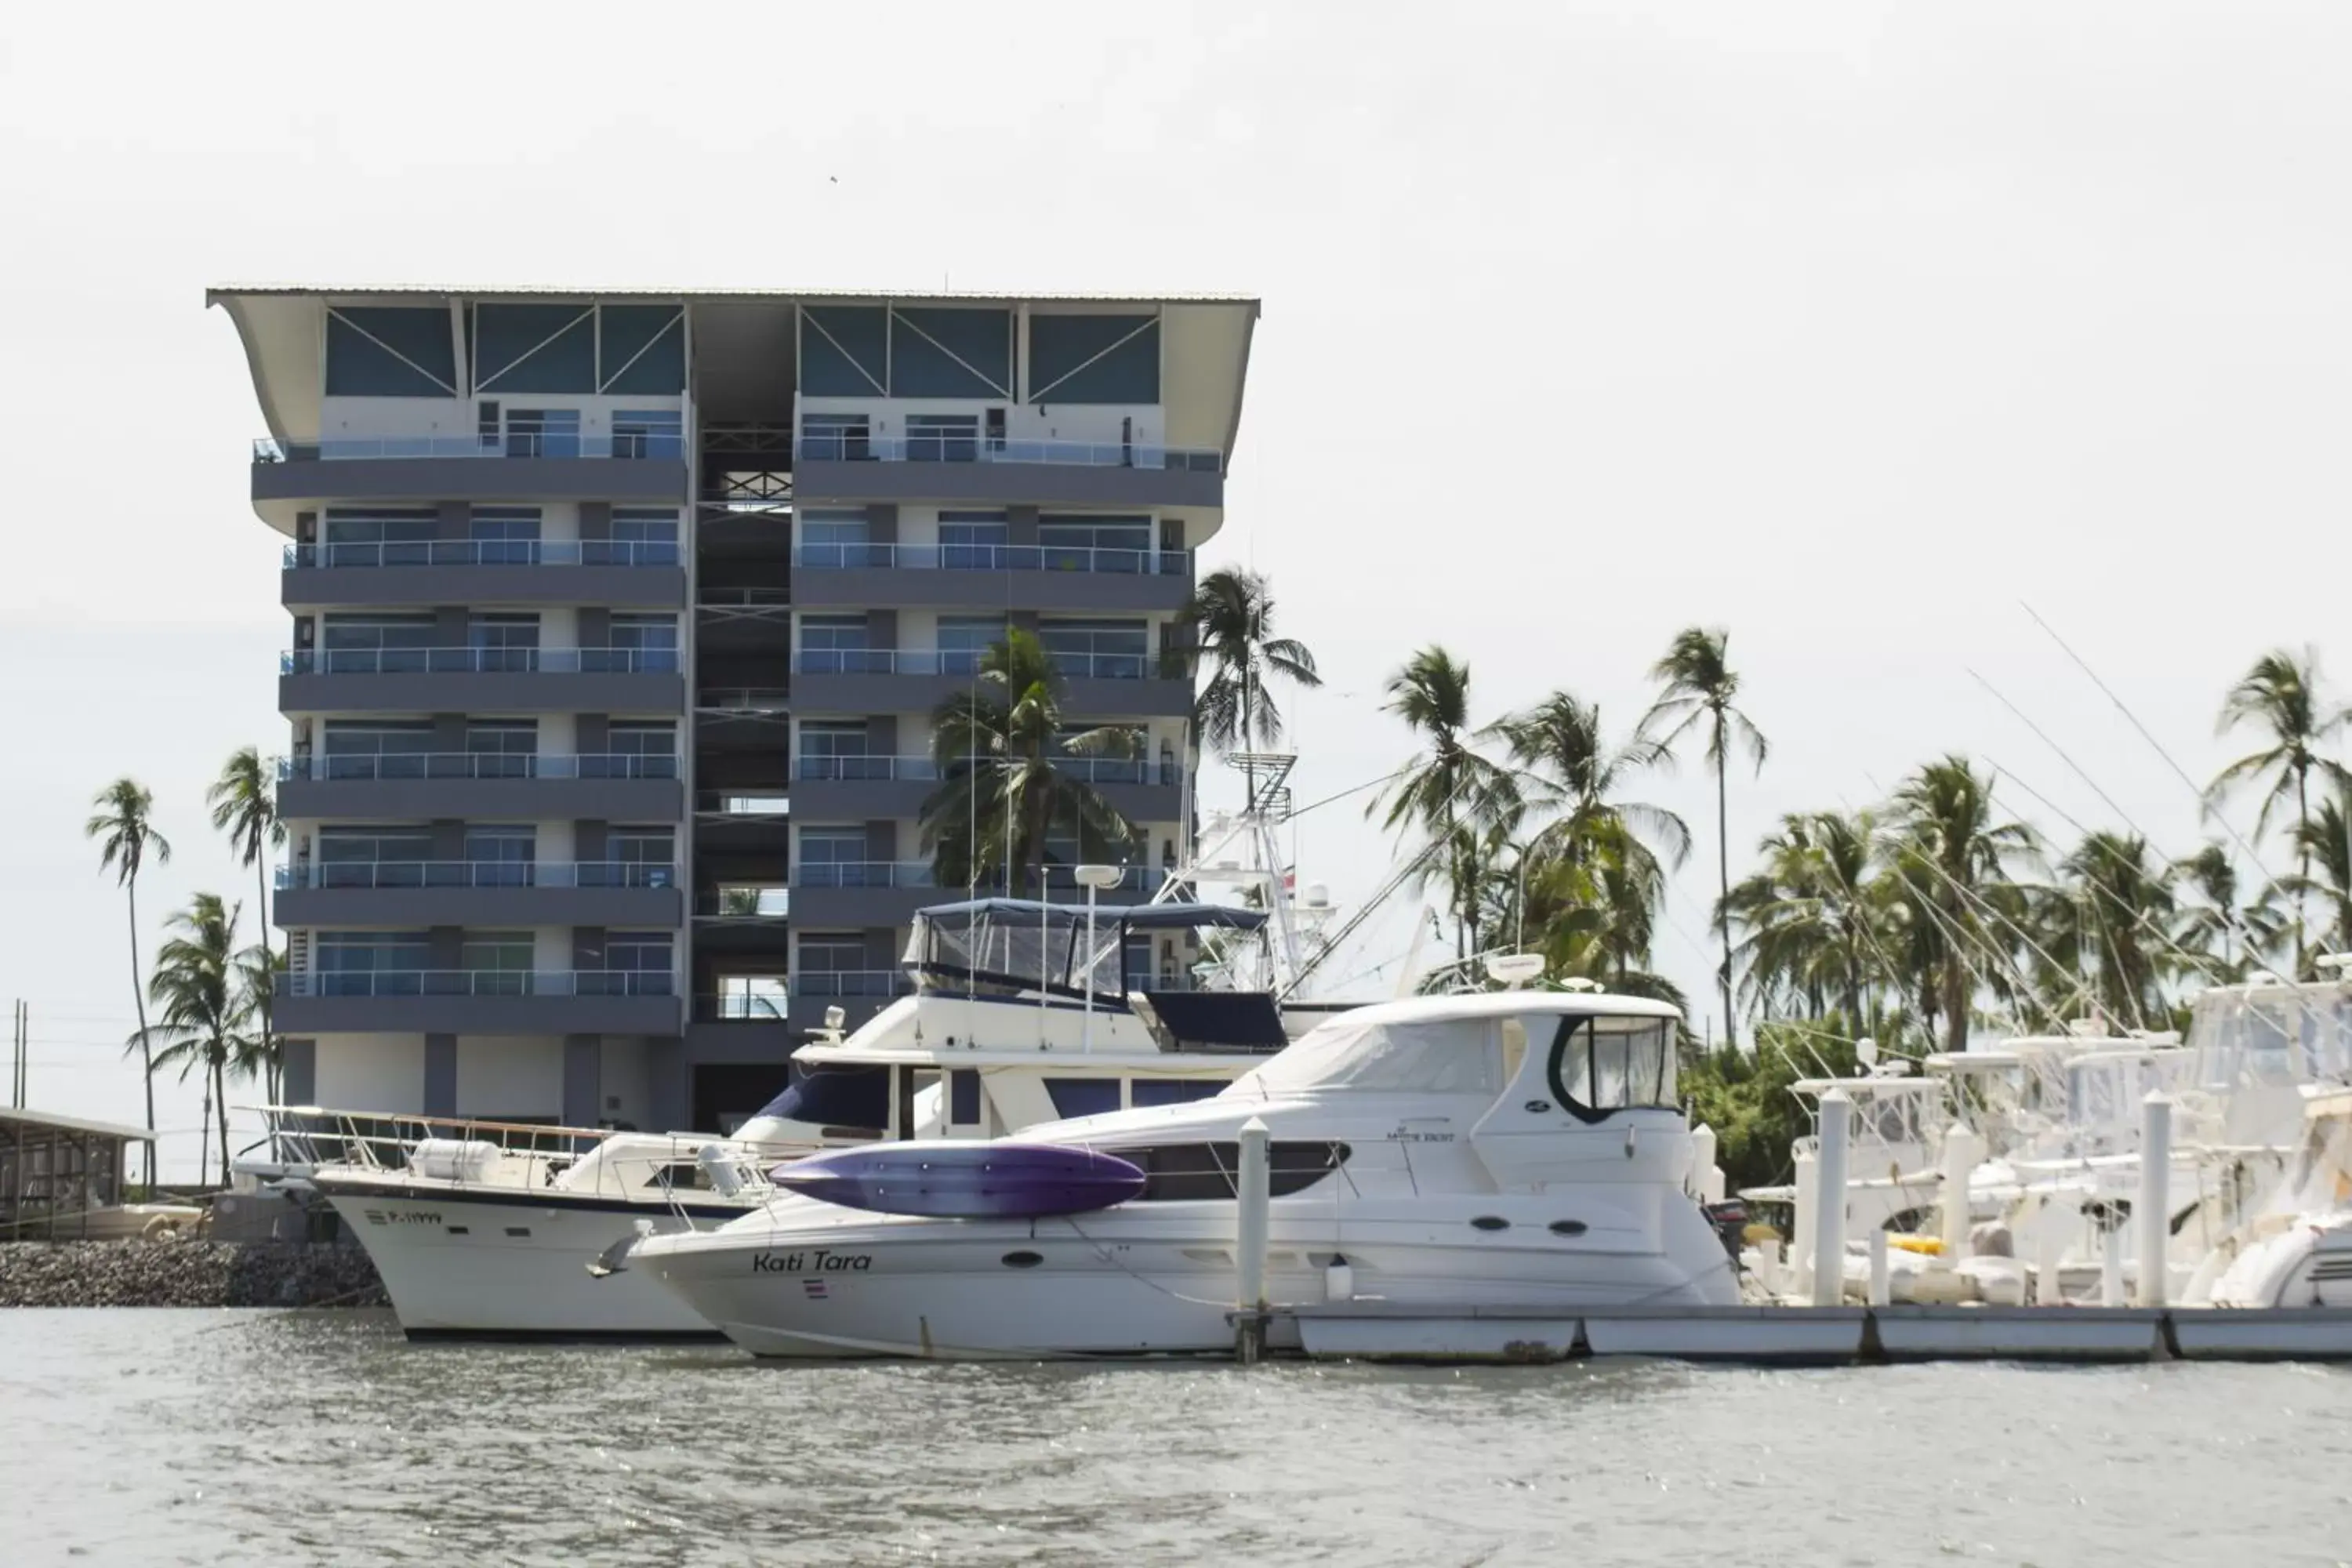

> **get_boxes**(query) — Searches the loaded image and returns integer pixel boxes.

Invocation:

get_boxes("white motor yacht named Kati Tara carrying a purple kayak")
[628,992,1740,1359]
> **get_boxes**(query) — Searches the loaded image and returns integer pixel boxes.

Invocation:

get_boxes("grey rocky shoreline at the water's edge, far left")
[0,1241,390,1307]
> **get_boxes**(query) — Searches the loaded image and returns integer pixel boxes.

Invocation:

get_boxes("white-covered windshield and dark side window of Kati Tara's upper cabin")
[1225,1013,1675,1121]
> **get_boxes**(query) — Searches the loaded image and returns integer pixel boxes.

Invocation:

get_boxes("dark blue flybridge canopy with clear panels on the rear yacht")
[903,898,1265,996]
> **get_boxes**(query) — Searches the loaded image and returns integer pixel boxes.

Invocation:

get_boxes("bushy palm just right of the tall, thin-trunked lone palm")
[1726,811,1893,1032]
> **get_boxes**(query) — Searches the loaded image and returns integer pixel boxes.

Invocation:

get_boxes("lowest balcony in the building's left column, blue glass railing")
[270,968,684,1034]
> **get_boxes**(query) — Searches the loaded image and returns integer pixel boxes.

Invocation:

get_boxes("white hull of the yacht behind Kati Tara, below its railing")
[327,1189,739,1340]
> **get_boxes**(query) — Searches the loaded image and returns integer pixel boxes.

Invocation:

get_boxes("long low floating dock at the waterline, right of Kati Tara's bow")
[1268,1300,2352,1366]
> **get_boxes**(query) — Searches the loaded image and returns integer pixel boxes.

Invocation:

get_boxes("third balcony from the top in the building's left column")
[278,649,687,713]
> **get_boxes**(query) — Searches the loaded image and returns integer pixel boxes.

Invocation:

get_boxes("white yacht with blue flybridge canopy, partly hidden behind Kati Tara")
[289,898,1319,1338]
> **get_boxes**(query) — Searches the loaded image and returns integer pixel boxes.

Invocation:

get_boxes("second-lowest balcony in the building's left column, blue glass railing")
[270,860,684,928]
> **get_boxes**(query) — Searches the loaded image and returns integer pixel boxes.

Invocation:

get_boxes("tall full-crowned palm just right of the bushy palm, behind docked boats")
[1889,753,2039,1051]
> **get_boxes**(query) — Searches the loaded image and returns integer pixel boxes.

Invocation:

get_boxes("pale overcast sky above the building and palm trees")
[0,0,2352,1175]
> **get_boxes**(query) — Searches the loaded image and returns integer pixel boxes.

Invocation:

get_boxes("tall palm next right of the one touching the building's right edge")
[1364,644,1519,964]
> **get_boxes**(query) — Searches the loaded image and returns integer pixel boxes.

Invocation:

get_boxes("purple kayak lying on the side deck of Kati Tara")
[769,1140,1143,1220]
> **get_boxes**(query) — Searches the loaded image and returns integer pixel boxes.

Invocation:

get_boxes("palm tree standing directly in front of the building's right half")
[922,628,1136,898]
